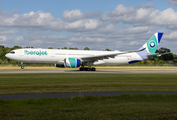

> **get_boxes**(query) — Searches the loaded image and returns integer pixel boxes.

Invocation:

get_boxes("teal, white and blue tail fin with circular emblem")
[138,32,163,60]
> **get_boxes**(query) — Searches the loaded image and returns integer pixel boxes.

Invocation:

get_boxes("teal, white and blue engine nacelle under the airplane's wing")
[64,58,81,68]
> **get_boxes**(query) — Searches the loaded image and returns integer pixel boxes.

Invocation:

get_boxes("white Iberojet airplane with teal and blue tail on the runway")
[5,32,169,71]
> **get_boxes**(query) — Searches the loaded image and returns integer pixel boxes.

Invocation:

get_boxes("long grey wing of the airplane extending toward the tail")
[81,48,146,62]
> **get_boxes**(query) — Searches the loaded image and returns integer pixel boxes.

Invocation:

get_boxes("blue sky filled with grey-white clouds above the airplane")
[0,0,177,53]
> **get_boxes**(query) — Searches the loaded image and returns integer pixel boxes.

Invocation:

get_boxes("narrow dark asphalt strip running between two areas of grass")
[0,91,177,100]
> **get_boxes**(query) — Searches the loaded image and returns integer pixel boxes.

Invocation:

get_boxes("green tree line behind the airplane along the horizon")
[0,45,177,65]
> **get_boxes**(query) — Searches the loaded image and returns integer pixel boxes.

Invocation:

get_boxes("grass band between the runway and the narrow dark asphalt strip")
[0,73,177,94]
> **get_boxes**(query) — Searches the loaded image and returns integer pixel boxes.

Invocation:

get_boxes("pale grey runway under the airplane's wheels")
[0,69,177,74]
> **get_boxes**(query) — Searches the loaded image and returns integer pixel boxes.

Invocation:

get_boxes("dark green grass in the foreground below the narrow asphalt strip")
[0,94,177,120]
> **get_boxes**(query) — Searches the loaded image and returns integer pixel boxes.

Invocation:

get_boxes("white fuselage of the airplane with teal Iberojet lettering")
[6,49,143,65]
